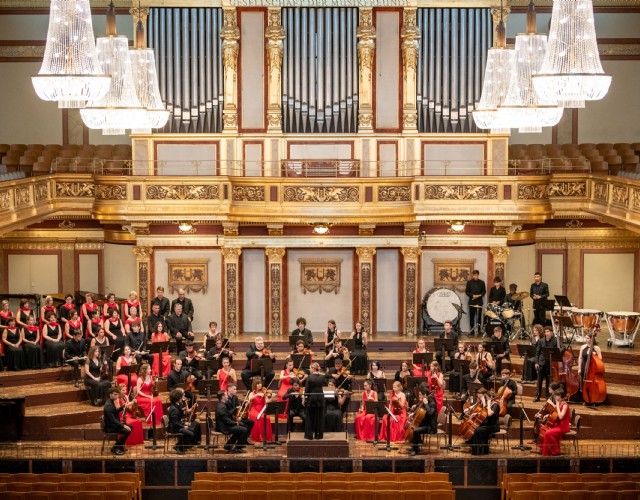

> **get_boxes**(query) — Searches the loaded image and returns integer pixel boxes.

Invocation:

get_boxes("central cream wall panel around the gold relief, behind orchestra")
[285,250,355,338]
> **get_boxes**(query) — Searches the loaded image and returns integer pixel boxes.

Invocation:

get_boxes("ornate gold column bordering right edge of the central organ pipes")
[356,9,376,132]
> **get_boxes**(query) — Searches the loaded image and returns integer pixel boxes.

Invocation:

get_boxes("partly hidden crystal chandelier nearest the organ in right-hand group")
[473,8,515,133]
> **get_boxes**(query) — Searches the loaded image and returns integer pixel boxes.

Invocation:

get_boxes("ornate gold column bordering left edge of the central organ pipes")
[265,8,285,132]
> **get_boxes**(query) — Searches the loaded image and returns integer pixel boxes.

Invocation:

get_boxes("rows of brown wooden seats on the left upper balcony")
[0,144,131,180]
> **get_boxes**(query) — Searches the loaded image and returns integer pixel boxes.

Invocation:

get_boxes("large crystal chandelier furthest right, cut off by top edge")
[533,0,611,108]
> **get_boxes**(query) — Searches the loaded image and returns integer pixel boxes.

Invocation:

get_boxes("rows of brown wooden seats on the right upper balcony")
[509,142,640,175]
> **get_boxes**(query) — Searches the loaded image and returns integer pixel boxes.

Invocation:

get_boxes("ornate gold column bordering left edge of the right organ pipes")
[400,8,420,132]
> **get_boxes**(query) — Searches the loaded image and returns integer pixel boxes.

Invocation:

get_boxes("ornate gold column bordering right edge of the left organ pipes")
[220,8,240,132]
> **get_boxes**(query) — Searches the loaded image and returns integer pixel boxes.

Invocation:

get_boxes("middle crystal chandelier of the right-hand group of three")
[497,0,563,133]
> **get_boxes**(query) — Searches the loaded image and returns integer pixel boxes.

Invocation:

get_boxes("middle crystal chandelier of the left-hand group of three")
[80,1,145,135]
